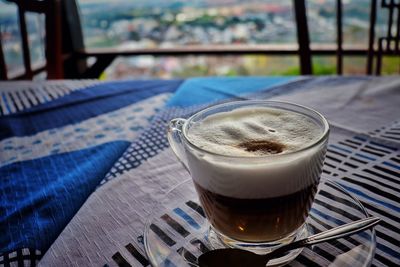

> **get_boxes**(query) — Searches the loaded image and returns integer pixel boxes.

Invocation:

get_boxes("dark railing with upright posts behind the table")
[0,0,400,79]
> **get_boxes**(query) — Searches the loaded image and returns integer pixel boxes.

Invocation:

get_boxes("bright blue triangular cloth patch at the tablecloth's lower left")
[0,141,129,254]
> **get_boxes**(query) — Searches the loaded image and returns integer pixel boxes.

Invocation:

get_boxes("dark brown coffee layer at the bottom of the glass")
[195,183,317,242]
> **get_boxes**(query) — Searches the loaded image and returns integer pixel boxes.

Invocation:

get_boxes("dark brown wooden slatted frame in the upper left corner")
[0,0,64,80]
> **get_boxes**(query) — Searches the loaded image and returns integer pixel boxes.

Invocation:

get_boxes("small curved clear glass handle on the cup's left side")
[167,118,189,171]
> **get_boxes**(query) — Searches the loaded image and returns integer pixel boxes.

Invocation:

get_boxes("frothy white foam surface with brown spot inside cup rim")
[187,107,322,157]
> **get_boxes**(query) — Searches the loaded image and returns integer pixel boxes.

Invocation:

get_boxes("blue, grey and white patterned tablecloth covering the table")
[0,77,400,266]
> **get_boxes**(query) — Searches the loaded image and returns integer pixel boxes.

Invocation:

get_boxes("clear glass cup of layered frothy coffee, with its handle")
[168,100,329,266]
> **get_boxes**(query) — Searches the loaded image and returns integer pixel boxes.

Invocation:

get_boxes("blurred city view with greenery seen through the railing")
[0,0,400,79]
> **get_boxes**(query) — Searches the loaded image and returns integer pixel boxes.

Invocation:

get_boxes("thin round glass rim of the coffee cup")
[182,100,330,160]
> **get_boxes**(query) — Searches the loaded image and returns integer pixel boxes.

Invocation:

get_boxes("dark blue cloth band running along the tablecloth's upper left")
[0,80,182,140]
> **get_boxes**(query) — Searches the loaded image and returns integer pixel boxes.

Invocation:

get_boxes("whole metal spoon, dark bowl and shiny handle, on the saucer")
[198,217,381,267]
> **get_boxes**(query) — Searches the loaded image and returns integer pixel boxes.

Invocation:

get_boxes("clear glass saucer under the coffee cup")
[144,179,376,267]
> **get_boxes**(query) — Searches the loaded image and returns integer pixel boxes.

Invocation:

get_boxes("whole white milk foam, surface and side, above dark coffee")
[186,107,326,198]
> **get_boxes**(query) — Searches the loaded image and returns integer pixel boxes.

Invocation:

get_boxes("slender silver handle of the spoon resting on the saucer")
[264,217,381,260]
